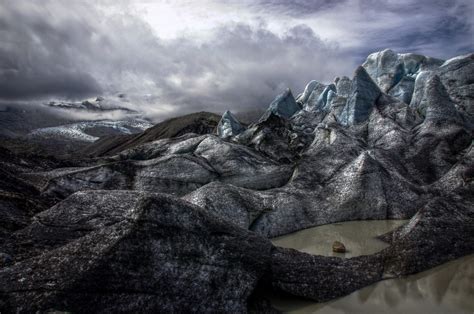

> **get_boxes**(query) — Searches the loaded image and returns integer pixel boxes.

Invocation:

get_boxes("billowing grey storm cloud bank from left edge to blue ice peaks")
[0,1,353,117]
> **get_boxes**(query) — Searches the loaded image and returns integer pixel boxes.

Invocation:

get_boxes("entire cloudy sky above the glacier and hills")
[0,0,474,119]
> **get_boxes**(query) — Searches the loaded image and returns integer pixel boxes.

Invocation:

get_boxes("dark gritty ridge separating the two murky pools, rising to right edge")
[266,184,474,302]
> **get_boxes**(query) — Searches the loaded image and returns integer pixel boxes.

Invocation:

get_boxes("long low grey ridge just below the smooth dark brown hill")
[42,133,292,198]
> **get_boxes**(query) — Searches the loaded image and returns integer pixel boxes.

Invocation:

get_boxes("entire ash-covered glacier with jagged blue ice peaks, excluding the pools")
[0,50,474,313]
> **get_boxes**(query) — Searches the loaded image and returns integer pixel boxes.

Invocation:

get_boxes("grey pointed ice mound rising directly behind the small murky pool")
[190,124,428,237]
